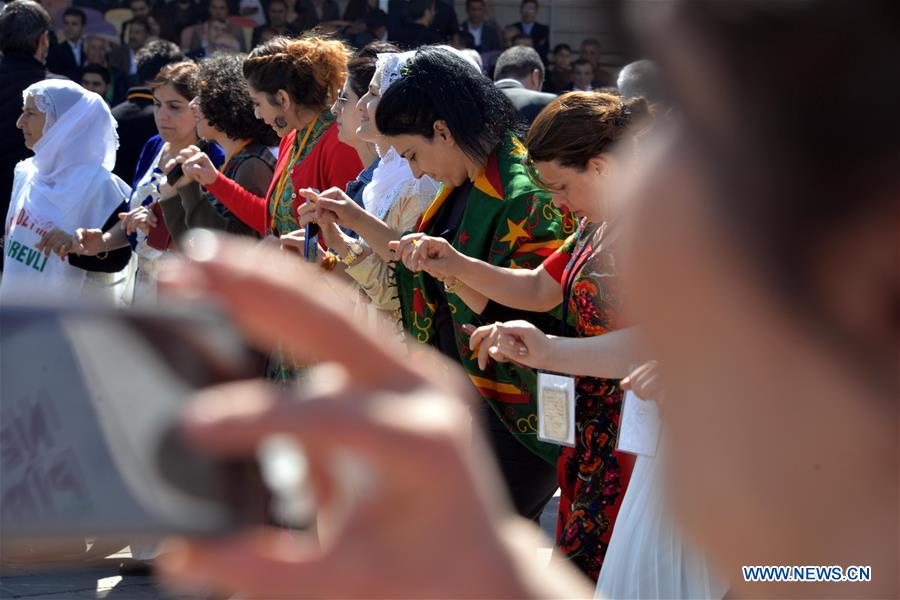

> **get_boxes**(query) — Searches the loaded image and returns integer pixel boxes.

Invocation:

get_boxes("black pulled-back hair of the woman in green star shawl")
[375,46,516,163]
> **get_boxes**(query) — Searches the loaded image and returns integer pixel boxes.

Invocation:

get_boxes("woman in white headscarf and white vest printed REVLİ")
[0,79,131,300]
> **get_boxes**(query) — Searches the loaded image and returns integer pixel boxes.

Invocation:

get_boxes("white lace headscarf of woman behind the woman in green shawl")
[363,51,439,220]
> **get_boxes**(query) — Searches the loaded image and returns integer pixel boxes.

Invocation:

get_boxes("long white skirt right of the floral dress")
[596,452,728,600]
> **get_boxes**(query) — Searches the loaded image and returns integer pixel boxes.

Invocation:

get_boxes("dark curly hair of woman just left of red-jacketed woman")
[197,53,278,146]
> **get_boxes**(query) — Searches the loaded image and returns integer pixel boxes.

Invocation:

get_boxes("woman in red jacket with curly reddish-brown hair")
[172,35,363,236]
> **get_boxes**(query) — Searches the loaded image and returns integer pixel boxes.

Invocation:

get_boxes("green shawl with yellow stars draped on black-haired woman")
[396,133,576,464]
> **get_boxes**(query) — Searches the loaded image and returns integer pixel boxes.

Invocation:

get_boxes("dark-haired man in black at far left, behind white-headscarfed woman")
[0,0,51,268]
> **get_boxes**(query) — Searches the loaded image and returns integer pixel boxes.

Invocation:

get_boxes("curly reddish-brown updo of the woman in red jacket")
[244,34,351,112]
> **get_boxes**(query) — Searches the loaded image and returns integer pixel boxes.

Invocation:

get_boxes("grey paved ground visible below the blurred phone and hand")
[0,496,559,600]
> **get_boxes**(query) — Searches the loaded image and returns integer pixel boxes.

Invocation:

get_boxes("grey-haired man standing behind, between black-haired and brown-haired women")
[494,46,556,127]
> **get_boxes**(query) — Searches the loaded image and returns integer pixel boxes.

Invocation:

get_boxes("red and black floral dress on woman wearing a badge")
[545,222,634,581]
